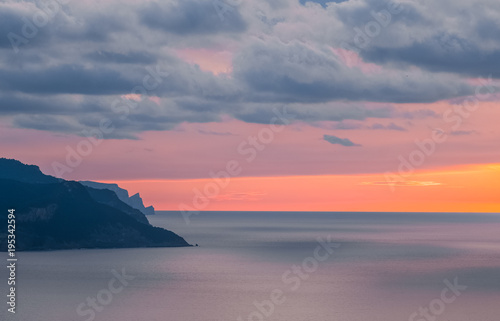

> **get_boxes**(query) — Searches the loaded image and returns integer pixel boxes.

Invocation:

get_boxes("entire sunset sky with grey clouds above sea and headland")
[0,0,500,212]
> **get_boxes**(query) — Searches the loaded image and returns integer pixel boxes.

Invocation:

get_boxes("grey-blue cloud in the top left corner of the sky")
[0,0,130,50]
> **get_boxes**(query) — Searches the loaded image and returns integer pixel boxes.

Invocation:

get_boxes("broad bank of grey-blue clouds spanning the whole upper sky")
[0,0,500,138]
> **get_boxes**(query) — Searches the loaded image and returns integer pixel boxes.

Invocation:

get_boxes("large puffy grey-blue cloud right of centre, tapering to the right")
[234,38,472,103]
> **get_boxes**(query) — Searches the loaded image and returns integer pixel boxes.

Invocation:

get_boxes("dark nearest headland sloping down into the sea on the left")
[0,158,190,251]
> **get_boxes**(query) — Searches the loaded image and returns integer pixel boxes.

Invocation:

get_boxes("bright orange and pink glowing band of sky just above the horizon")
[101,164,500,213]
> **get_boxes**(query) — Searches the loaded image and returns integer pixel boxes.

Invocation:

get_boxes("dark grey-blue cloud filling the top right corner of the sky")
[352,0,500,77]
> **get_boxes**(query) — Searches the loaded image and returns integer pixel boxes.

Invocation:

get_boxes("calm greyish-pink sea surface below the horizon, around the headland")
[0,212,500,321]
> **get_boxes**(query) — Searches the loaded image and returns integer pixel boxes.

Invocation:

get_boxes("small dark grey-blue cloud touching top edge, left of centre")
[138,0,246,35]
